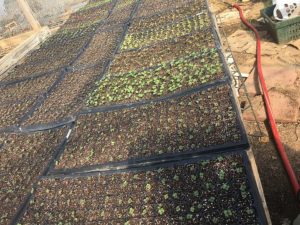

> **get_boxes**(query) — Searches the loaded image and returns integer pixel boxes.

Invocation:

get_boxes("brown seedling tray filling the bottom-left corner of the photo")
[0,126,65,225]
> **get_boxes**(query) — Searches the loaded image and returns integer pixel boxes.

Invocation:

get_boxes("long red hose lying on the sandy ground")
[233,4,300,201]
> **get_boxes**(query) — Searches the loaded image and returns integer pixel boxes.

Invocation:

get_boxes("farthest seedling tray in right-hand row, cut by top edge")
[135,0,198,18]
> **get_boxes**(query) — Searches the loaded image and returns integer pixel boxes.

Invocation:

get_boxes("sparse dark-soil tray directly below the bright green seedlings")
[56,85,244,169]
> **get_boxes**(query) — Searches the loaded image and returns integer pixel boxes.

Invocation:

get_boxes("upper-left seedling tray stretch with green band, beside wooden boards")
[1,1,115,83]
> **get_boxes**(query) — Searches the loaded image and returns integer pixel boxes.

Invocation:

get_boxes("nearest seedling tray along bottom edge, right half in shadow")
[20,154,265,225]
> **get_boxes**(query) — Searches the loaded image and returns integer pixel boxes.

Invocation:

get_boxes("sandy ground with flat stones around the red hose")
[210,0,300,225]
